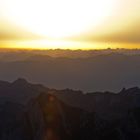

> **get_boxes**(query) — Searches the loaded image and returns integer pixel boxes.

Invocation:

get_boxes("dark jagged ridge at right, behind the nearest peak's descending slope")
[54,87,140,120]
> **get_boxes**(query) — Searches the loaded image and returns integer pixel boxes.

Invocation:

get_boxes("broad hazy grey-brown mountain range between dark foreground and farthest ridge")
[0,52,140,92]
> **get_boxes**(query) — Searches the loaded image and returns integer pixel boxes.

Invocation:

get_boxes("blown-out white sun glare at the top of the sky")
[2,0,117,38]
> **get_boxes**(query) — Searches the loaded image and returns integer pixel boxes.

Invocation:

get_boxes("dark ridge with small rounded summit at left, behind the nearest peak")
[0,78,48,104]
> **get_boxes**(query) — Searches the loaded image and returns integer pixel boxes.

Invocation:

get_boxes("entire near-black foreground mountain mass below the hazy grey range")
[0,78,140,140]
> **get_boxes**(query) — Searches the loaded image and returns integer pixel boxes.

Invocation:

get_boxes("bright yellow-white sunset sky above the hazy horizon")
[0,0,140,49]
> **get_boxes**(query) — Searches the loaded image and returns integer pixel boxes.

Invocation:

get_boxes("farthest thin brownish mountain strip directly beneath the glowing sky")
[0,46,140,61]
